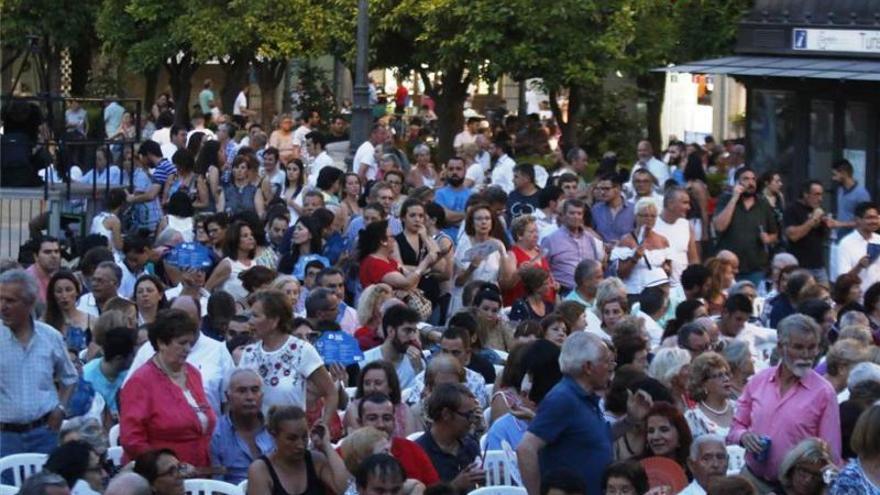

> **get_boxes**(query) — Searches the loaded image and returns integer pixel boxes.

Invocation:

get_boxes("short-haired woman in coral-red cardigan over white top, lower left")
[119,309,217,468]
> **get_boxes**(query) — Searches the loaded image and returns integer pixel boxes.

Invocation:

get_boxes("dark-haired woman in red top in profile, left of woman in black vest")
[358,220,437,290]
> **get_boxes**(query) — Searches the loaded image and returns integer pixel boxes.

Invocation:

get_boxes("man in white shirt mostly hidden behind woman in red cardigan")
[122,296,235,416]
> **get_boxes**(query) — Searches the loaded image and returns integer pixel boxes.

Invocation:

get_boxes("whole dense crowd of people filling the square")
[0,94,880,495]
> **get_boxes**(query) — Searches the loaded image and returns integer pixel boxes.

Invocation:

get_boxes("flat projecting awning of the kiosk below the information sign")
[654,56,880,81]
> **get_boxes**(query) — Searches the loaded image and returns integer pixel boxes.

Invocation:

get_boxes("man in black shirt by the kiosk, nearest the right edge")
[783,180,835,282]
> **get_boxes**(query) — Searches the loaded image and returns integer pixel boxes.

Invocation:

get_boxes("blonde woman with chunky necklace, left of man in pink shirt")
[684,352,736,438]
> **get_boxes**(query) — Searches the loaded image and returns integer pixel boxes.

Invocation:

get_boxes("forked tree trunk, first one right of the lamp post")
[426,67,470,163]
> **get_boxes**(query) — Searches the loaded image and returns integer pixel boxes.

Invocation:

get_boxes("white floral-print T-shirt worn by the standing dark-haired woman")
[238,335,324,415]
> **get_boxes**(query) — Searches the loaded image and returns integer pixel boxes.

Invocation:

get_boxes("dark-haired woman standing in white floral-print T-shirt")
[239,290,338,424]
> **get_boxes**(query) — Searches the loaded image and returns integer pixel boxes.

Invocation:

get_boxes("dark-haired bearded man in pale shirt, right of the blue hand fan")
[361,304,425,389]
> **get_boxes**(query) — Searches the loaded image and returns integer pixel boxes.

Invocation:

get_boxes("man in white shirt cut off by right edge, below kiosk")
[837,202,880,293]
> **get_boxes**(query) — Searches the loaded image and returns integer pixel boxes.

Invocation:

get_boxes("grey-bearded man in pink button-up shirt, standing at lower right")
[727,314,841,493]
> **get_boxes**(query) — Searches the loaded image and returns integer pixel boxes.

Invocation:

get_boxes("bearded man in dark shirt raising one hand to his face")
[712,167,778,285]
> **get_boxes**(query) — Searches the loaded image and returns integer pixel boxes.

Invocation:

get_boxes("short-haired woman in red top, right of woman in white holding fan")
[501,215,559,306]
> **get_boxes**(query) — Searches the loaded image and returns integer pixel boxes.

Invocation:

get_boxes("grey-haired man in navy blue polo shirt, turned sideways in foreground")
[516,332,651,495]
